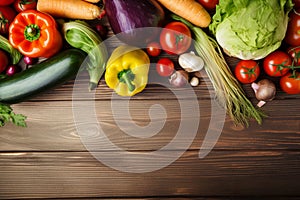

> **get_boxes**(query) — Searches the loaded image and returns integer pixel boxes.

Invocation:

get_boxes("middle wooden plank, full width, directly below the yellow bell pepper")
[0,99,300,151]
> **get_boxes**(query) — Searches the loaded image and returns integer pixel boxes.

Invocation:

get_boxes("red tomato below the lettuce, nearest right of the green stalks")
[234,60,260,84]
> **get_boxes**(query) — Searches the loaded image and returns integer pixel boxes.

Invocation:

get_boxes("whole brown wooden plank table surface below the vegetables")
[0,19,300,199]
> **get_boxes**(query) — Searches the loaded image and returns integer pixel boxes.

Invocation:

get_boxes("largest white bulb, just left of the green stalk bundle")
[178,51,204,72]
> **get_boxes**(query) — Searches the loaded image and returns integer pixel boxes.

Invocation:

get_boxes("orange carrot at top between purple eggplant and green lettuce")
[157,0,211,28]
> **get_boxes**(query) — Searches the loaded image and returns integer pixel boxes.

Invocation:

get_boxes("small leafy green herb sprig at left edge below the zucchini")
[0,103,27,127]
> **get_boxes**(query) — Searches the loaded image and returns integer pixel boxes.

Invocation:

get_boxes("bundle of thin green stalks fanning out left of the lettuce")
[172,15,266,127]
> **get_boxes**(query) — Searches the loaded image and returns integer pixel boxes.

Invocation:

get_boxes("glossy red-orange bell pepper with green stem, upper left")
[9,10,63,58]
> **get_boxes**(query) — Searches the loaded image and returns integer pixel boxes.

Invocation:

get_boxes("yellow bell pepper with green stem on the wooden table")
[105,45,150,96]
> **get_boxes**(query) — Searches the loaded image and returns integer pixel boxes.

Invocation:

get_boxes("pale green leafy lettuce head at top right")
[209,0,293,60]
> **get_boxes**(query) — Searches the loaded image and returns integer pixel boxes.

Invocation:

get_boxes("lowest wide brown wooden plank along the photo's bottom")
[0,150,300,198]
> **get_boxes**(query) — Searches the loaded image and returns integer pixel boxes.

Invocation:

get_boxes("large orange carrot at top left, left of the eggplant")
[37,0,103,20]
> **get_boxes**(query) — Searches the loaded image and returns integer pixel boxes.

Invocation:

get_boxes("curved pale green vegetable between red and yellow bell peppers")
[63,20,108,91]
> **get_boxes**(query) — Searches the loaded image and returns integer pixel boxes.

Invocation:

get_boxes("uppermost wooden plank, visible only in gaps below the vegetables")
[18,69,300,102]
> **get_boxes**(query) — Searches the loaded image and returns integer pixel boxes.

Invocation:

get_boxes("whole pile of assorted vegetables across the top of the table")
[0,0,300,126]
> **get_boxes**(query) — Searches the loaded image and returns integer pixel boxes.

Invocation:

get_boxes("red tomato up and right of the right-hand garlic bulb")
[263,50,292,76]
